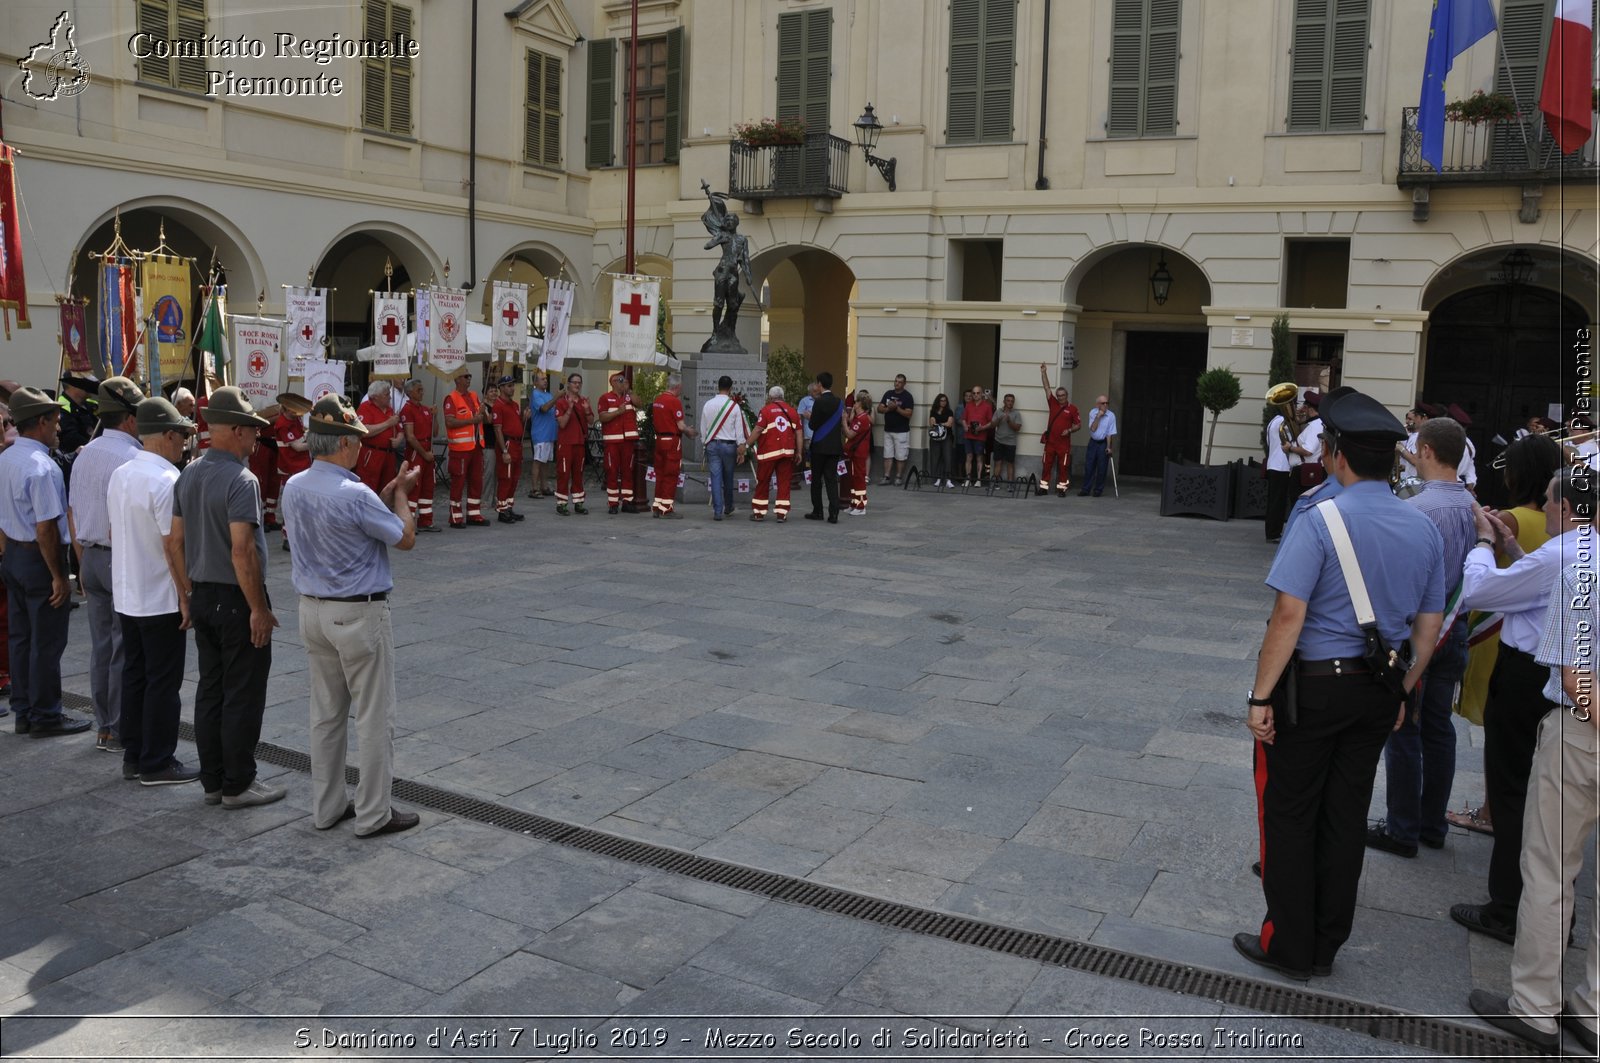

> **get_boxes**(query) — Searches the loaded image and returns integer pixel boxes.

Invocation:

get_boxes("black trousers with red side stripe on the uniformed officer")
[1256,676,1400,970]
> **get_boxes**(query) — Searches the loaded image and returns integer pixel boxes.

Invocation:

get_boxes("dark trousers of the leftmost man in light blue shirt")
[0,540,72,724]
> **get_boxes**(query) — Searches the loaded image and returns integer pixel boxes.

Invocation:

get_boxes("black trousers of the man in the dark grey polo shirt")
[189,583,272,797]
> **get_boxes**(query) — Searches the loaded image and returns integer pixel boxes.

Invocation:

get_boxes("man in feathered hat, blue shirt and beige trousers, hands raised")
[282,395,419,837]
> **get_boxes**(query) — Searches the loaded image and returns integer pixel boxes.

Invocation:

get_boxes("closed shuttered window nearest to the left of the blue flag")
[1286,0,1371,133]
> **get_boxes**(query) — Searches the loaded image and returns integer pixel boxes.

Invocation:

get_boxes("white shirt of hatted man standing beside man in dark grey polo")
[106,450,178,616]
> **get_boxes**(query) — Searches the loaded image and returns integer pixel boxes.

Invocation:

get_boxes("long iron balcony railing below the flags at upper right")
[1398,107,1600,187]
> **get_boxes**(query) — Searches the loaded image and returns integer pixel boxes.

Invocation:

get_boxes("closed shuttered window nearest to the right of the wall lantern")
[944,0,1016,144]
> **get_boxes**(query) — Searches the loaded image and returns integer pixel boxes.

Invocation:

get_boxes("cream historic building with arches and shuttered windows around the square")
[0,0,1600,474]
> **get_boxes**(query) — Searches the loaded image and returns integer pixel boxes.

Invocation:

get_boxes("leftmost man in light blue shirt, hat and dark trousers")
[0,387,90,738]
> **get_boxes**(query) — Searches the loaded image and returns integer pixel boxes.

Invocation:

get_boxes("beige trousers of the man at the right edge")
[1509,708,1600,1033]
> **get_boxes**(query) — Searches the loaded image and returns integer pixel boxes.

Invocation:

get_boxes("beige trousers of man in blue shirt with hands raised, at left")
[299,596,395,834]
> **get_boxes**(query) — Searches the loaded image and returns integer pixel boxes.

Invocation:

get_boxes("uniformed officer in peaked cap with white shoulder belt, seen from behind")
[1234,392,1445,980]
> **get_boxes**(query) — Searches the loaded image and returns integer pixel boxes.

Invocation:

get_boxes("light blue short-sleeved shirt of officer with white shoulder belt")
[1267,480,1445,661]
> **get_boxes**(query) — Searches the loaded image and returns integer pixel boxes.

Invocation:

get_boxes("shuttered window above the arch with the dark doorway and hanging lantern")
[1106,0,1182,136]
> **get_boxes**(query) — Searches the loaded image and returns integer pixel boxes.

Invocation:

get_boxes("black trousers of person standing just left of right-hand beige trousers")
[1483,642,1555,927]
